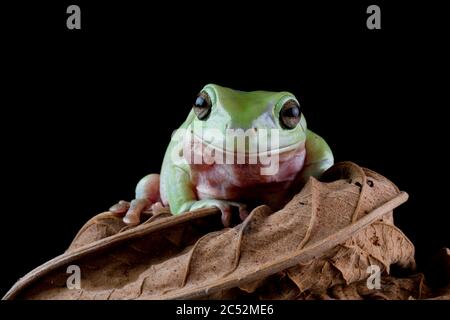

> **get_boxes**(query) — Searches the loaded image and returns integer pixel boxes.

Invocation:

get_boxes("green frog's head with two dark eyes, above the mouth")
[187,84,306,156]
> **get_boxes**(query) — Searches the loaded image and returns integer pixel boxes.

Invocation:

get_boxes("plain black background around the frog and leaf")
[0,1,449,300]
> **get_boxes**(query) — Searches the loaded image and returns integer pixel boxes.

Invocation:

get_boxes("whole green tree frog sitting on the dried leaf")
[110,84,334,226]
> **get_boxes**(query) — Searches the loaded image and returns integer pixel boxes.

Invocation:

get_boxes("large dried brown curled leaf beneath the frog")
[2,162,436,299]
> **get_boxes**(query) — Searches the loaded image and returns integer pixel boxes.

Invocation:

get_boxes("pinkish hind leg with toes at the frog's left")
[109,174,161,225]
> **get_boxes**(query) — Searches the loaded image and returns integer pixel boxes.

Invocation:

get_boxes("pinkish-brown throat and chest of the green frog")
[186,144,306,209]
